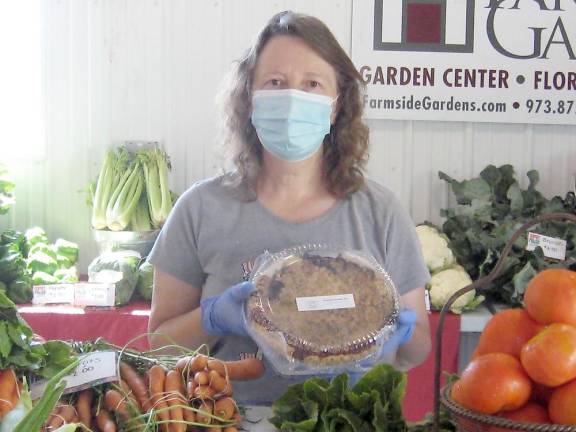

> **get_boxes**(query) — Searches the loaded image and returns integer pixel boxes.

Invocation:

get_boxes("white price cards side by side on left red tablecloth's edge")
[32,282,116,306]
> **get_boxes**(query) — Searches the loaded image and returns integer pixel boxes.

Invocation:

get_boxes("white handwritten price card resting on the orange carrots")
[30,351,118,399]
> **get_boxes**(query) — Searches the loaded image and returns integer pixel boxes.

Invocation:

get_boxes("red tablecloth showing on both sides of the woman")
[19,303,460,421]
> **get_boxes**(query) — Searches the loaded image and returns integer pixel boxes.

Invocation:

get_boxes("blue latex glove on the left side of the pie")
[200,282,254,336]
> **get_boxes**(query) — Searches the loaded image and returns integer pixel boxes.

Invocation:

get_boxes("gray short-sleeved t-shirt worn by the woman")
[148,176,430,404]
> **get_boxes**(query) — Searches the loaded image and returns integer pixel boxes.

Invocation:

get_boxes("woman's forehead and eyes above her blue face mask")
[252,35,338,109]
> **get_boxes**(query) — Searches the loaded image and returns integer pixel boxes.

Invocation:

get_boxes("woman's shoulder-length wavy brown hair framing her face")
[219,11,369,198]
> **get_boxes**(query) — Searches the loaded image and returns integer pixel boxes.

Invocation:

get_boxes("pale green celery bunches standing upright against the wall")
[88,147,173,231]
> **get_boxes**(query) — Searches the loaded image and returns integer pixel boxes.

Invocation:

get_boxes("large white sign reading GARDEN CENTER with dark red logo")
[352,0,576,125]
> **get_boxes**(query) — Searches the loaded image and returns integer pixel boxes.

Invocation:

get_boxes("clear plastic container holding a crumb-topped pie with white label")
[244,245,399,375]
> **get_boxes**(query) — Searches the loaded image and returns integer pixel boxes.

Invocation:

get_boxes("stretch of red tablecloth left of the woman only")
[18,302,150,351]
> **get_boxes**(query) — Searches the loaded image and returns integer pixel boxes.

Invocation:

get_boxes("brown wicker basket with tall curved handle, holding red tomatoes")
[434,213,576,432]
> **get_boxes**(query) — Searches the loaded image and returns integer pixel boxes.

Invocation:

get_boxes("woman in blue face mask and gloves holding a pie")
[149,12,430,404]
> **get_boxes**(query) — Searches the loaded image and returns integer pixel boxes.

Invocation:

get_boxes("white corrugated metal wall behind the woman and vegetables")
[0,0,576,270]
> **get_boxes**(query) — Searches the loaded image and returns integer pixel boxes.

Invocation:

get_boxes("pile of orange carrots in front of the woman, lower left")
[43,354,264,432]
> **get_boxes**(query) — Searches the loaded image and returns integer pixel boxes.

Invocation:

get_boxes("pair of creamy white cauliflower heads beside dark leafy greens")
[426,264,484,314]
